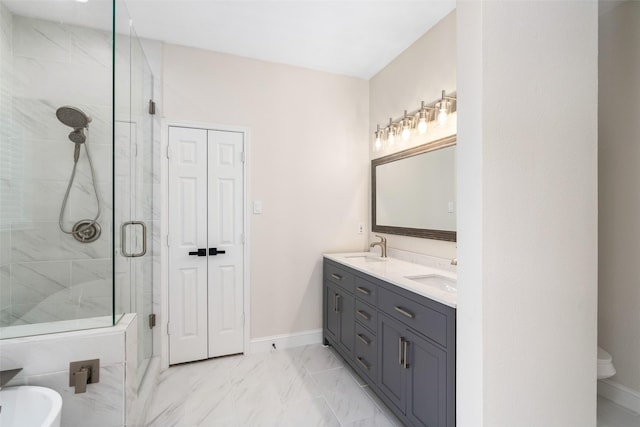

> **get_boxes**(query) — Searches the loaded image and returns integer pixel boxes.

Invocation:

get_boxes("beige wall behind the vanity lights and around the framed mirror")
[367,11,456,258]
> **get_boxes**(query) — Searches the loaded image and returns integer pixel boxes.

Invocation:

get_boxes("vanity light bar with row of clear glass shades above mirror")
[373,90,457,151]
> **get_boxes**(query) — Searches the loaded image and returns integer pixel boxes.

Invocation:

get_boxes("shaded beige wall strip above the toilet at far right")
[598,1,640,394]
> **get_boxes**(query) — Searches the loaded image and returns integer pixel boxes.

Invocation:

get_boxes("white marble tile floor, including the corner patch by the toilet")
[145,344,640,427]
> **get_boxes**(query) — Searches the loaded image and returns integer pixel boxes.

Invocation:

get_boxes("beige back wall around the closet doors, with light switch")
[163,45,369,338]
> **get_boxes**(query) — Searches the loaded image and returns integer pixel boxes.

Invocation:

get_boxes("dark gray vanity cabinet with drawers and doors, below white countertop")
[324,259,456,427]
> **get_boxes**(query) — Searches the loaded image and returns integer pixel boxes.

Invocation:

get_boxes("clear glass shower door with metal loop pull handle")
[114,2,159,381]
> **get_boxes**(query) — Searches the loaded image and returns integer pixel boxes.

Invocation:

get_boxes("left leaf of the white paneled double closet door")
[169,127,208,364]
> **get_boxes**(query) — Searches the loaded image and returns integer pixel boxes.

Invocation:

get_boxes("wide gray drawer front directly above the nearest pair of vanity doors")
[378,287,447,347]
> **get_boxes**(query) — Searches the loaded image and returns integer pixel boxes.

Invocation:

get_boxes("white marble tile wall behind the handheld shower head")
[0,14,113,326]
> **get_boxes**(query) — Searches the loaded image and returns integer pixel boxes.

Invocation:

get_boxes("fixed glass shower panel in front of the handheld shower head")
[0,0,114,338]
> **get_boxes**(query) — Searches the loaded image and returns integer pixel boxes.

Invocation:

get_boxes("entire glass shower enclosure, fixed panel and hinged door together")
[0,0,160,384]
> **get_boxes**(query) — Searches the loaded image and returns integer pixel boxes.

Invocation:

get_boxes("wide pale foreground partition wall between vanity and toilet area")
[457,0,598,427]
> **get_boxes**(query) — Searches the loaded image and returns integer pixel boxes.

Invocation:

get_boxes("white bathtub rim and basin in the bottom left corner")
[0,386,62,427]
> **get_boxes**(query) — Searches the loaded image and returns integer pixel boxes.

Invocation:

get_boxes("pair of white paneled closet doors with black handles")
[169,126,244,364]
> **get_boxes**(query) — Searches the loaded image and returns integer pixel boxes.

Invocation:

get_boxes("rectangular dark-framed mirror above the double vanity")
[371,135,456,242]
